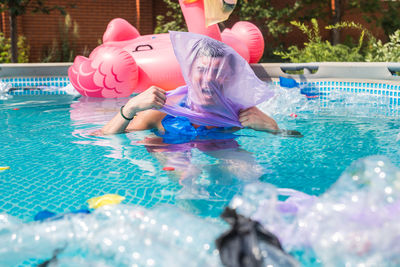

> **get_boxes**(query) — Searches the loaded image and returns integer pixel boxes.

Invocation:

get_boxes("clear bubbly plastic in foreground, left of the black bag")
[0,205,227,266]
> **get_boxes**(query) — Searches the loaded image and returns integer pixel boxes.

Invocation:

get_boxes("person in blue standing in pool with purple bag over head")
[101,32,300,140]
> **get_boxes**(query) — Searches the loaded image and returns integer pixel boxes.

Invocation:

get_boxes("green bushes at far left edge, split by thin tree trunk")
[0,32,30,63]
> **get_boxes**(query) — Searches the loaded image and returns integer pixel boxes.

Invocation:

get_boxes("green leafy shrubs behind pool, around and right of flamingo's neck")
[155,0,400,62]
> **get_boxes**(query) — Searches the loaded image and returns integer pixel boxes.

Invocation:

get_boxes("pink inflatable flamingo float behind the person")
[68,0,264,98]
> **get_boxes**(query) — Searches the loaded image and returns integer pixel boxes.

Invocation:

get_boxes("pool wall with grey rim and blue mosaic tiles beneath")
[0,62,400,106]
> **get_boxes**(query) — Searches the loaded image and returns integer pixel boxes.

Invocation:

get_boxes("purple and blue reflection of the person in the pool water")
[140,137,264,216]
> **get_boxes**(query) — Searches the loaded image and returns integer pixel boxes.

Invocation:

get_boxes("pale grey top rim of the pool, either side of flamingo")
[0,62,400,81]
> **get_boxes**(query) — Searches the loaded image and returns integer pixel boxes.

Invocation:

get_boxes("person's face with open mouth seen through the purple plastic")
[191,56,227,106]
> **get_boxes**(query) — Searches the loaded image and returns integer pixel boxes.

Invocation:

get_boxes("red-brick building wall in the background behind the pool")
[0,0,390,62]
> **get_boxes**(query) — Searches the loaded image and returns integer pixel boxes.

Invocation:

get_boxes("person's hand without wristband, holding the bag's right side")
[239,107,279,133]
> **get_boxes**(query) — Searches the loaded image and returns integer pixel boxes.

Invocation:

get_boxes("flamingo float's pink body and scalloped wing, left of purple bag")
[68,18,184,98]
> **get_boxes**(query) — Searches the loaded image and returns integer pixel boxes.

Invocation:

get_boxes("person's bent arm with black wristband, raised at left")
[100,86,166,135]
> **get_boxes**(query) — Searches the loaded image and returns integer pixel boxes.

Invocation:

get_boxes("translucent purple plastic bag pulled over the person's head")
[161,32,274,127]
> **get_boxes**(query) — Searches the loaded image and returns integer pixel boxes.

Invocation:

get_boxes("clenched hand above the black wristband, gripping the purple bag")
[124,86,167,117]
